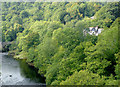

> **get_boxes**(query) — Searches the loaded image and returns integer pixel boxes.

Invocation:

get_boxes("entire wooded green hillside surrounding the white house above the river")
[2,2,120,85]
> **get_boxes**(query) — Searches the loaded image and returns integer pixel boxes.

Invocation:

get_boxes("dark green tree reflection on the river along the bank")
[17,59,45,83]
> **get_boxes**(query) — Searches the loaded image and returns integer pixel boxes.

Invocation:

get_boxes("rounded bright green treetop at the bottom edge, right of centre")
[60,70,105,85]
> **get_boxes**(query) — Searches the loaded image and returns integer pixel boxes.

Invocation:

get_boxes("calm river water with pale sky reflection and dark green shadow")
[0,53,45,85]
